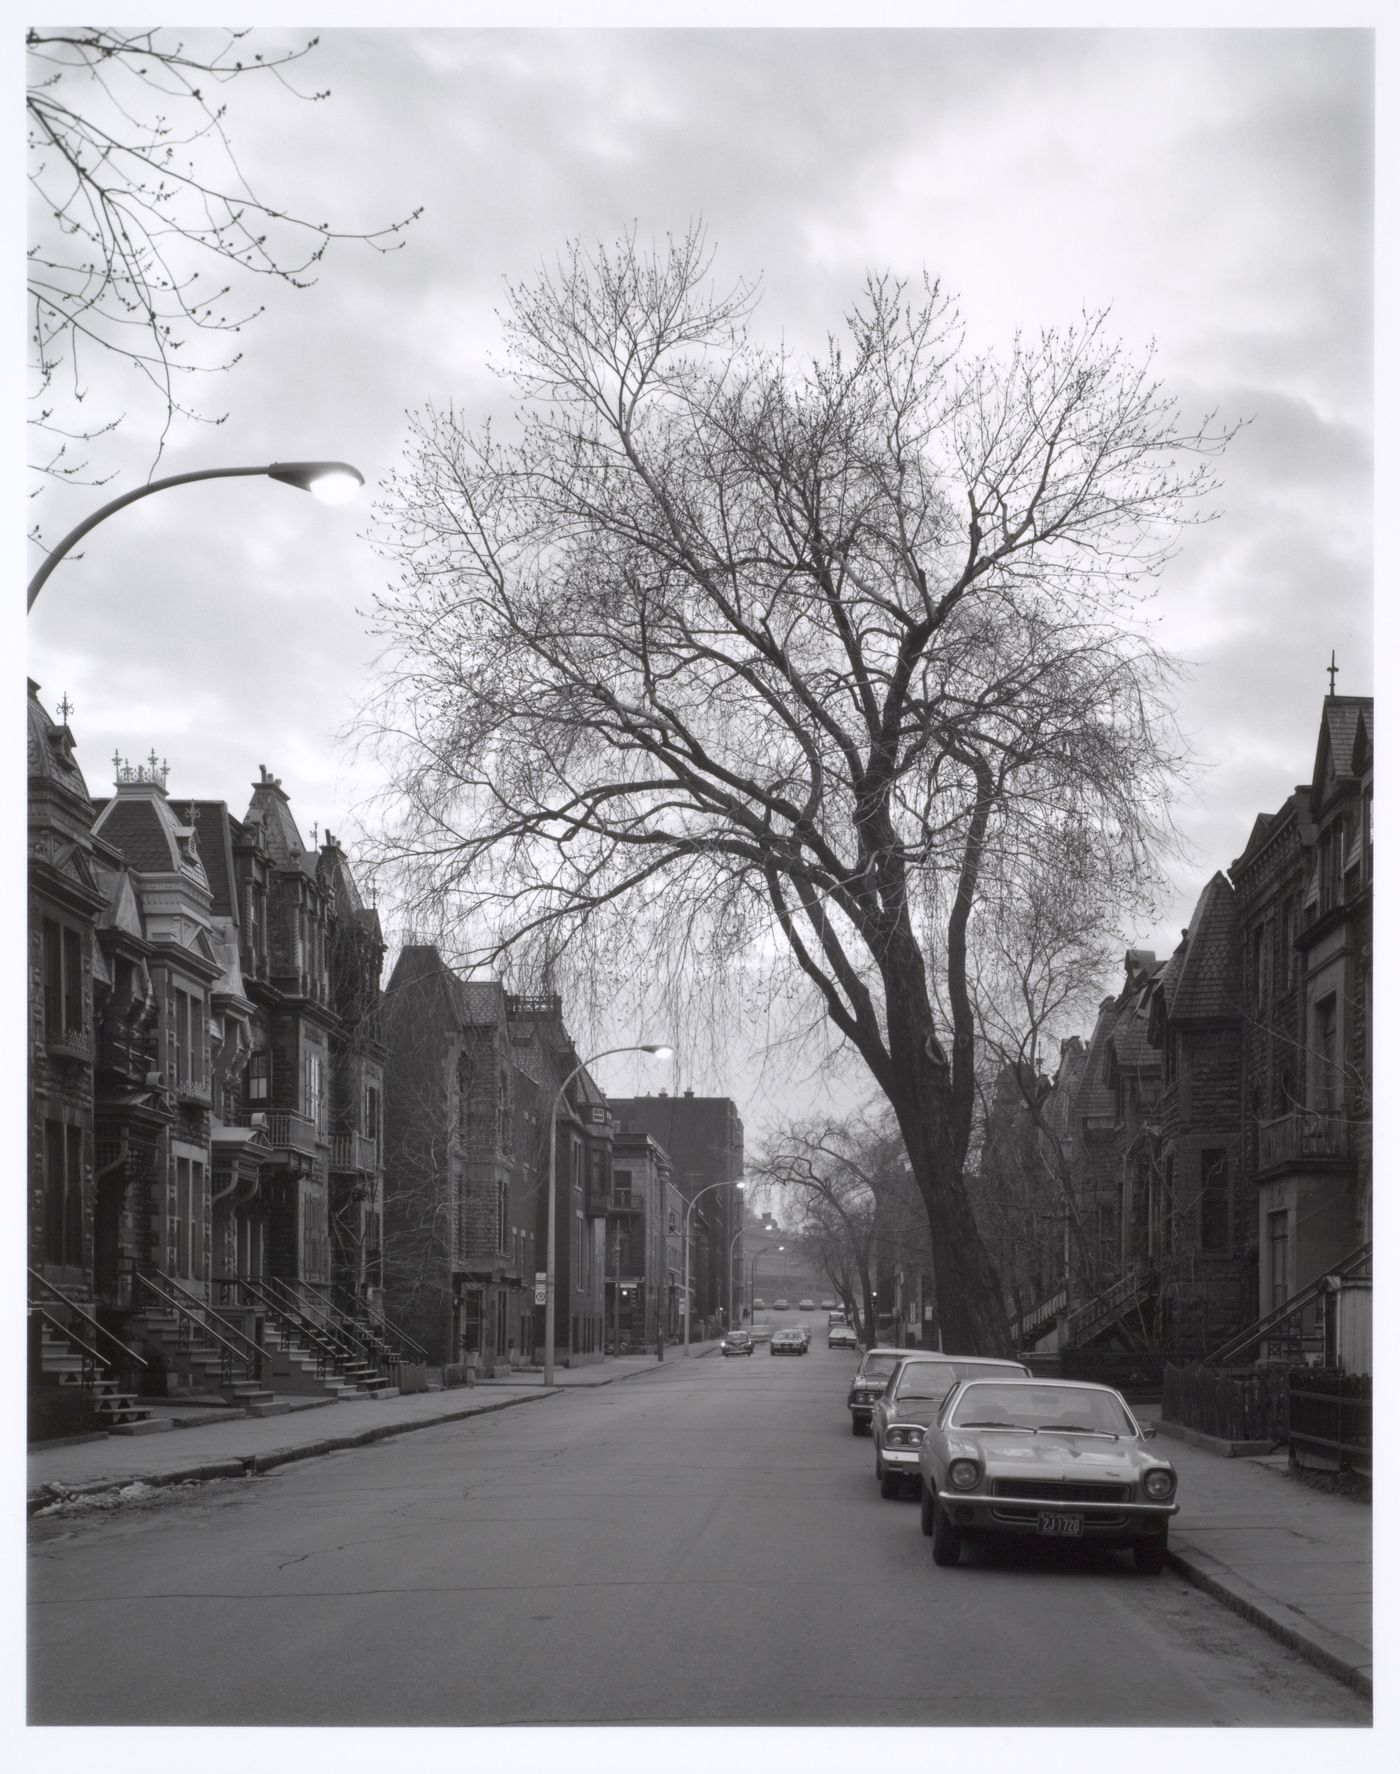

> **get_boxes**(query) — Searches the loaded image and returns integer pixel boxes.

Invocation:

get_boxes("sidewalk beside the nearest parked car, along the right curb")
[1148,1416,1372,1696]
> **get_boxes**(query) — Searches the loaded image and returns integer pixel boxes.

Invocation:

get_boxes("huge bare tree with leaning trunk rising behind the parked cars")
[371,231,1223,1352]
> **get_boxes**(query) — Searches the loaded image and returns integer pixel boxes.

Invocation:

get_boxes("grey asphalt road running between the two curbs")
[28,1332,1368,1728]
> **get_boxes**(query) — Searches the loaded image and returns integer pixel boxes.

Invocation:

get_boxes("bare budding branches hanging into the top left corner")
[25,27,421,496]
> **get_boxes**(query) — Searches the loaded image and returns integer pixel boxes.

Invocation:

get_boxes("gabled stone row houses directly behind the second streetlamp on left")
[380,944,612,1375]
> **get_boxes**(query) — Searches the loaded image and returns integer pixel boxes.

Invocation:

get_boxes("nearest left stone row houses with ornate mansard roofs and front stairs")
[27,685,383,1433]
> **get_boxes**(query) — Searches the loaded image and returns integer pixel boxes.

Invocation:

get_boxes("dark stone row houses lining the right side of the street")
[983,695,1373,1364]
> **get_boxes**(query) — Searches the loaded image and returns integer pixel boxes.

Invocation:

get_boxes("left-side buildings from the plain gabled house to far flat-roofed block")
[380,944,743,1375]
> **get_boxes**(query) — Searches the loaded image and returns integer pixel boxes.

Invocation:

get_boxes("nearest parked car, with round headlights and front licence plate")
[917,1377,1176,1575]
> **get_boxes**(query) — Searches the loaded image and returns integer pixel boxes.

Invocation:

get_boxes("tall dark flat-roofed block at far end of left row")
[612,1091,743,1334]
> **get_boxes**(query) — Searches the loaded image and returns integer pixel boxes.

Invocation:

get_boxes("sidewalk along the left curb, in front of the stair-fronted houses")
[27,1343,719,1513]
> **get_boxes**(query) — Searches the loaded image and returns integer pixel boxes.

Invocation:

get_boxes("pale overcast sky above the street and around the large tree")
[28,14,1373,1128]
